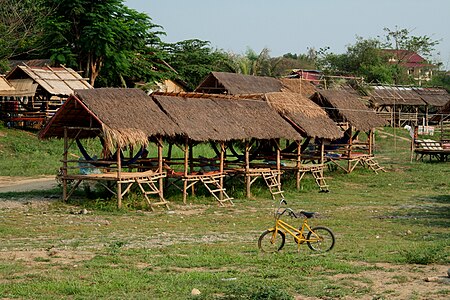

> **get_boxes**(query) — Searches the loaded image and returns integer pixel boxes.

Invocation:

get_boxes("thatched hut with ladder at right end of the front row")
[312,90,385,172]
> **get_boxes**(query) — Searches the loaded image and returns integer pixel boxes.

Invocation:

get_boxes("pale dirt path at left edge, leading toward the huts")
[0,176,57,193]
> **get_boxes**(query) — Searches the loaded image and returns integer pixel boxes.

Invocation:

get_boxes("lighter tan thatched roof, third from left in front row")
[265,92,342,139]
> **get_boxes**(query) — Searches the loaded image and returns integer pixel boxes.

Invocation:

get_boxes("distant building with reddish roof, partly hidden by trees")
[383,49,436,85]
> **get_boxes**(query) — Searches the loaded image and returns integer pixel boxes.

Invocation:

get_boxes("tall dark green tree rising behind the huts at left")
[40,0,164,85]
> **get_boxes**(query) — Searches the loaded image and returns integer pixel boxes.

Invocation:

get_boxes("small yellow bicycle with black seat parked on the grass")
[258,199,335,253]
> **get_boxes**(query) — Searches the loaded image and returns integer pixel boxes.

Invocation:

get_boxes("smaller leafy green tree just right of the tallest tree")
[164,39,231,90]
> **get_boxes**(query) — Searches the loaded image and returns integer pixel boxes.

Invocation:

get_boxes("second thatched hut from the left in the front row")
[152,93,301,201]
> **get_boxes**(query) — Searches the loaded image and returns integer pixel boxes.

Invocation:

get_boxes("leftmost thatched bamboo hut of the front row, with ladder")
[39,88,183,207]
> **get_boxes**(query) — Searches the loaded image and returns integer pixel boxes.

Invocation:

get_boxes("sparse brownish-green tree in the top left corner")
[0,0,51,73]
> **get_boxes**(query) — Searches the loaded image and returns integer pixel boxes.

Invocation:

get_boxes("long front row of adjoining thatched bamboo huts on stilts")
[40,73,390,207]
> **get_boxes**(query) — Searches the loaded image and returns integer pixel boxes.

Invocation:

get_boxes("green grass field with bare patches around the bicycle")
[0,125,450,299]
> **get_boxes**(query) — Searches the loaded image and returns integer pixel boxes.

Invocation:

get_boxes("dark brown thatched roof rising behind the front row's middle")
[195,72,282,95]
